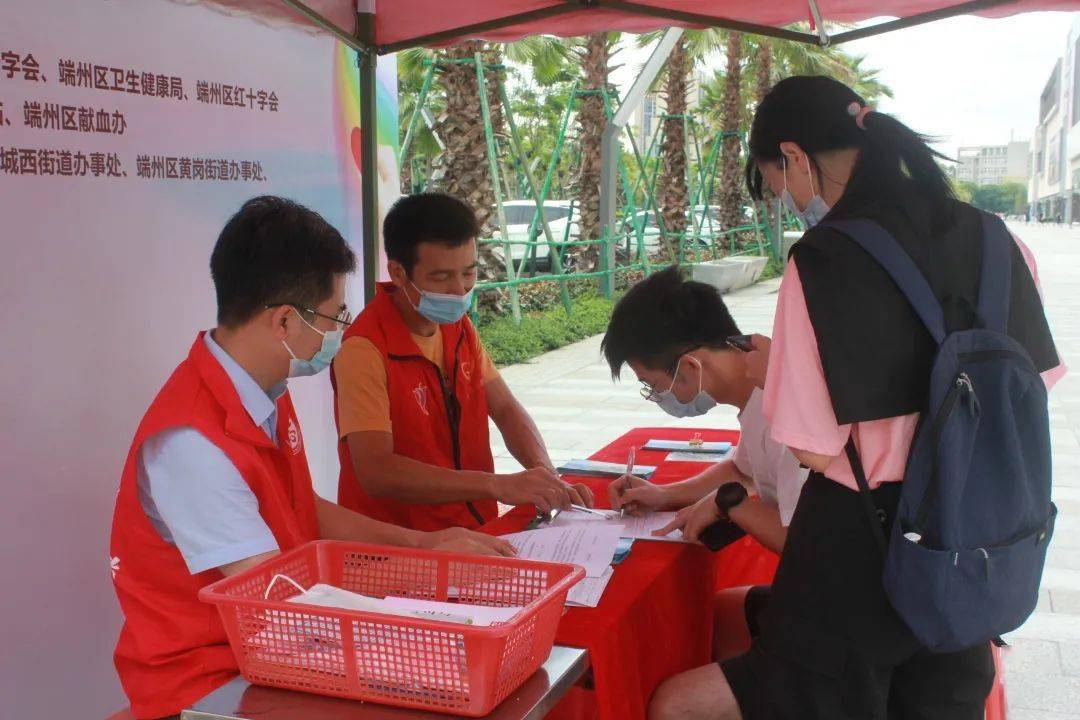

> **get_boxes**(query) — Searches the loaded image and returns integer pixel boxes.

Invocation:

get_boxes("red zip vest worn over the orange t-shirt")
[330,283,499,530]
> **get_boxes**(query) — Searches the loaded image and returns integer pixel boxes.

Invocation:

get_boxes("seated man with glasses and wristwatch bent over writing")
[602,268,808,657]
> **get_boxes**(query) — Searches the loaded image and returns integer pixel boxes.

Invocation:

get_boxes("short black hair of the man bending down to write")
[600,268,740,378]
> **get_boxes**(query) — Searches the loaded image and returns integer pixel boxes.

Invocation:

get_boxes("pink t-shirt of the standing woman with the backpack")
[765,235,1065,489]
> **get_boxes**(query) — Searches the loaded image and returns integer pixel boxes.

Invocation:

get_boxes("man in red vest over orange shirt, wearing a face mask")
[332,193,592,530]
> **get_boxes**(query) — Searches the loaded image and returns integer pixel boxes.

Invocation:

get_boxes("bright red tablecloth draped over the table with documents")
[485,427,778,720]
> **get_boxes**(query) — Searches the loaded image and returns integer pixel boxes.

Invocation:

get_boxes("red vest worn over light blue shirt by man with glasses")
[110,332,319,718]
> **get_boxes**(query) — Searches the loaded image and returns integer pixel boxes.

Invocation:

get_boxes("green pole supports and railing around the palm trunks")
[400,54,780,322]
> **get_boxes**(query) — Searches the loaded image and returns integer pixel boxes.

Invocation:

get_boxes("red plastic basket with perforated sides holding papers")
[199,540,584,717]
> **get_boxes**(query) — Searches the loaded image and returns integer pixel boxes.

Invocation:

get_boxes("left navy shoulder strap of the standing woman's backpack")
[816,219,946,344]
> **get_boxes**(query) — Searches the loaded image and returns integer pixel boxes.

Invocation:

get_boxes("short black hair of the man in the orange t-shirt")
[382,192,480,273]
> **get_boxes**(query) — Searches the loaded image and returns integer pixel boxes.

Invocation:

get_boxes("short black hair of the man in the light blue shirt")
[210,195,356,327]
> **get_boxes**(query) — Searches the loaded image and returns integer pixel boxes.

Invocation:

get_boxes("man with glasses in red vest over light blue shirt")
[110,196,512,718]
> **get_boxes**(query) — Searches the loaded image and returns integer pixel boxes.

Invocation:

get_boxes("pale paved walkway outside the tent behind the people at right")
[492,225,1080,720]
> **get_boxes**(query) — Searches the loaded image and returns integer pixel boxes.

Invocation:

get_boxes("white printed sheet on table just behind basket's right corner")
[502,520,622,578]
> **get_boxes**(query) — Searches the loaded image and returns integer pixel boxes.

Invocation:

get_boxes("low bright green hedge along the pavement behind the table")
[478,297,615,366]
